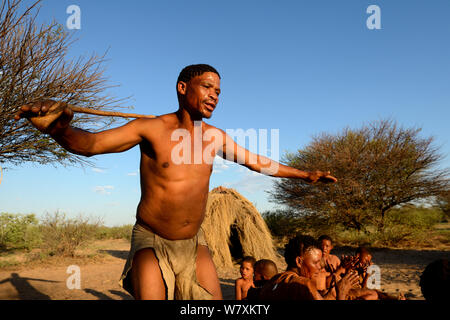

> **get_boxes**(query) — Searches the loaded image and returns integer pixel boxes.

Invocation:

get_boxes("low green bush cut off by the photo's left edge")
[0,213,41,250]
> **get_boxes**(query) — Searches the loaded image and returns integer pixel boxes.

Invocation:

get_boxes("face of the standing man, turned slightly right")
[177,72,220,119]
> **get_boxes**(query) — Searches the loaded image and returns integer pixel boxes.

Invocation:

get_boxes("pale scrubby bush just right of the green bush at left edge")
[40,212,101,257]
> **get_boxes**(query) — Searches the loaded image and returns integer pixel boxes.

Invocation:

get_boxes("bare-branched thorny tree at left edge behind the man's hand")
[0,0,130,169]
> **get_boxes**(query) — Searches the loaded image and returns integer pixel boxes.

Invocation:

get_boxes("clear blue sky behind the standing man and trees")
[0,0,450,225]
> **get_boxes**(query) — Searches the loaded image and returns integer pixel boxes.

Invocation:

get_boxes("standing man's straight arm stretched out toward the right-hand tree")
[220,130,337,183]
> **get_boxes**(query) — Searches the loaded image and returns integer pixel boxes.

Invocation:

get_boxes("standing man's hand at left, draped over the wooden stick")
[14,100,73,134]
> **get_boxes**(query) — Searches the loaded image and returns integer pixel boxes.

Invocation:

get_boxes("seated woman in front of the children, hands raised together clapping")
[259,235,358,300]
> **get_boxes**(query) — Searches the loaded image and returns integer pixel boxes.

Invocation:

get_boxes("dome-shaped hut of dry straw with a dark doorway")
[202,187,278,268]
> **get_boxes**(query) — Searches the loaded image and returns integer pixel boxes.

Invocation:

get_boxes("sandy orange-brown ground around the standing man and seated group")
[0,240,450,300]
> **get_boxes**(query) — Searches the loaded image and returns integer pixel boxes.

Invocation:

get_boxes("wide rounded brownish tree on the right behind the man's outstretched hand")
[271,120,449,230]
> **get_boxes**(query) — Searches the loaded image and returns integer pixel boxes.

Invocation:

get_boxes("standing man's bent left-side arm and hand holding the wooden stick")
[15,100,147,157]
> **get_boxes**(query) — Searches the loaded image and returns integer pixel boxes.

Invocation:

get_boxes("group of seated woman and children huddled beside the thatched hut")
[235,235,405,301]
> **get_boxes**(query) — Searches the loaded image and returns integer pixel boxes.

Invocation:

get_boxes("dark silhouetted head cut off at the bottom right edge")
[419,259,450,301]
